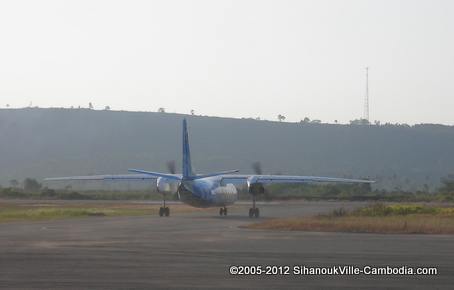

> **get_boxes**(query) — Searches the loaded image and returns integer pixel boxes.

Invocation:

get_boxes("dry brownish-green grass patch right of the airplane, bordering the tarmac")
[247,203,454,234]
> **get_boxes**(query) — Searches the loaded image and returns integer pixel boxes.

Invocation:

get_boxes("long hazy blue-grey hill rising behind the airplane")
[0,108,454,189]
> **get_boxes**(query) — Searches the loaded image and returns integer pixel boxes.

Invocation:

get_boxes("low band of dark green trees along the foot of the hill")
[0,175,454,202]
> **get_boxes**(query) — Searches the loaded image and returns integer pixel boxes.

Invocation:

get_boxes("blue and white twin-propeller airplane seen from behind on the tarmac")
[44,119,374,218]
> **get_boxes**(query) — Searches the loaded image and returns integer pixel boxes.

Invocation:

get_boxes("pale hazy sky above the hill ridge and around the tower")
[0,0,454,124]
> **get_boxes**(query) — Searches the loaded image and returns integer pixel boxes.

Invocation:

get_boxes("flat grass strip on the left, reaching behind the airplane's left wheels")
[0,202,207,223]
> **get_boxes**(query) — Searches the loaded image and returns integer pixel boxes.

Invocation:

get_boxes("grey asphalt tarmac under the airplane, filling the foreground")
[0,202,454,289]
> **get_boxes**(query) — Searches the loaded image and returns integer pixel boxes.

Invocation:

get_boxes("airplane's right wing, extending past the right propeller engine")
[222,174,375,184]
